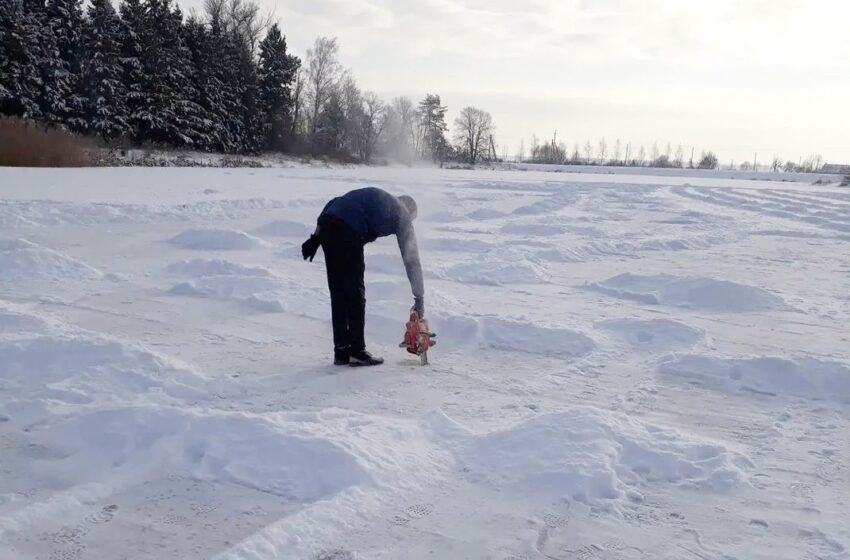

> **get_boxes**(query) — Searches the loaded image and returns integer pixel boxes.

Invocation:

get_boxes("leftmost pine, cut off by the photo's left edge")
[0,0,41,119]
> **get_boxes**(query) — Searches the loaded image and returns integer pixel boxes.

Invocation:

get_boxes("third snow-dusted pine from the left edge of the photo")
[83,0,129,140]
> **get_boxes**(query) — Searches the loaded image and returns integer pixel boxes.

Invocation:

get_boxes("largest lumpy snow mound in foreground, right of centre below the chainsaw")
[430,408,749,511]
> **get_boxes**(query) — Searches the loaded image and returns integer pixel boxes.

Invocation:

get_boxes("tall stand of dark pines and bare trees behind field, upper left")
[0,0,495,163]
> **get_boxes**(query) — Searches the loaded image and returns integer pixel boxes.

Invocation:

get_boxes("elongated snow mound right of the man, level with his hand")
[587,273,788,312]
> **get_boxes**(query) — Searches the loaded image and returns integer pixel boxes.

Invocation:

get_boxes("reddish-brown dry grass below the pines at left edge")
[0,117,94,167]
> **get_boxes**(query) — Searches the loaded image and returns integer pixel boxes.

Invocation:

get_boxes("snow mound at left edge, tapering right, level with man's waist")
[0,239,103,286]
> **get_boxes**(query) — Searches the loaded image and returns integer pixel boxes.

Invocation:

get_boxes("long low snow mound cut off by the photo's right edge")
[658,354,850,403]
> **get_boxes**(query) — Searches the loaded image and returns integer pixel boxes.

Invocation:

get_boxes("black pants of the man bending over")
[319,216,366,352]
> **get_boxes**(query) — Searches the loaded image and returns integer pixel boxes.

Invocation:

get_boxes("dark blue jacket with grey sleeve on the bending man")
[321,187,425,298]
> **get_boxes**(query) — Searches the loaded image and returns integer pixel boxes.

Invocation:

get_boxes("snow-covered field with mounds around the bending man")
[0,164,850,560]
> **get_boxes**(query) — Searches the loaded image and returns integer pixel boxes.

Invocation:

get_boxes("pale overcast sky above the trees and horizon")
[180,0,850,165]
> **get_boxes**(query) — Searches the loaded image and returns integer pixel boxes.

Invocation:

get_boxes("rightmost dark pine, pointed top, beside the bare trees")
[257,25,301,150]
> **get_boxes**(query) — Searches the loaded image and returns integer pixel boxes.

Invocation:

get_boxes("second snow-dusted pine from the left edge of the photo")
[42,0,86,132]
